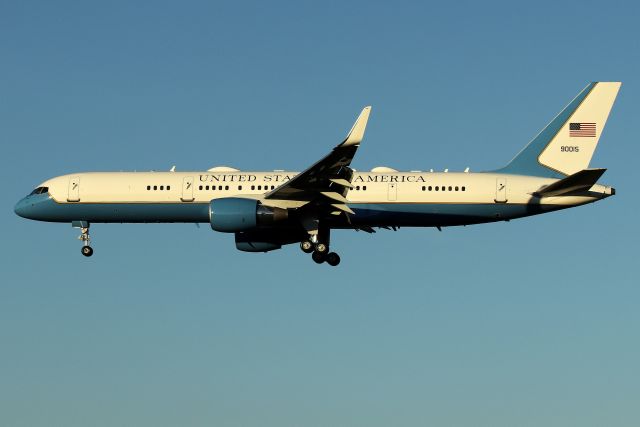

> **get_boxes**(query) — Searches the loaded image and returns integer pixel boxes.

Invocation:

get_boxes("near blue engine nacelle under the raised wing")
[209,197,289,232]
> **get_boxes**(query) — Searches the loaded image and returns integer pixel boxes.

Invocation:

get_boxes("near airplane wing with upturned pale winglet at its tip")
[265,107,371,213]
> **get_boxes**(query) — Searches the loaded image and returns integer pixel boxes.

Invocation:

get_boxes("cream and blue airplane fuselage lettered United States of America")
[16,171,614,228]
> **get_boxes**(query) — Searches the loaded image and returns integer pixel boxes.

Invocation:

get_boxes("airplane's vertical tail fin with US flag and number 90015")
[495,82,621,178]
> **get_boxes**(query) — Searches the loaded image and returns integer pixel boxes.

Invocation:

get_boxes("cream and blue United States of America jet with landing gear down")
[14,82,621,266]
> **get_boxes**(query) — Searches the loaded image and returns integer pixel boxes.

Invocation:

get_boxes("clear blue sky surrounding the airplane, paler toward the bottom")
[0,1,640,427]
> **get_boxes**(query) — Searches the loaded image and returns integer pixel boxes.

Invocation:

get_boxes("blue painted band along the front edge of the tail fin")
[491,82,597,178]
